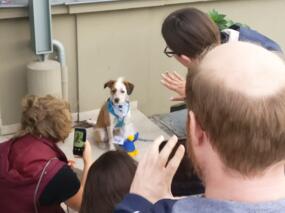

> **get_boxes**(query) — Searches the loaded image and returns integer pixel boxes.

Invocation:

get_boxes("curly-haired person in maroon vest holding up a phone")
[0,95,92,213]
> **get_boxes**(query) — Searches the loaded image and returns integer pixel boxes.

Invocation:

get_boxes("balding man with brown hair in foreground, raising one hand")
[114,42,285,213]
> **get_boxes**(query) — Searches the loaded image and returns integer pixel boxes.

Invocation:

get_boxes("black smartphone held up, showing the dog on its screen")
[73,128,86,156]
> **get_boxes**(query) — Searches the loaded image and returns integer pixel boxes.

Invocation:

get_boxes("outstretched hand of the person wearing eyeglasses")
[160,71,186,101]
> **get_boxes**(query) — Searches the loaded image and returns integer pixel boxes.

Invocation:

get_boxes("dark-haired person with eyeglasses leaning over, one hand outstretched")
[161,8,282,101]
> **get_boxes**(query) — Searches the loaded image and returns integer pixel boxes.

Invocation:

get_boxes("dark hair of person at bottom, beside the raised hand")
[80,151,137,213]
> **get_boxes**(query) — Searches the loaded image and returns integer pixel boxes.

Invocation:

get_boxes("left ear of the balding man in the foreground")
[188,111,206,146]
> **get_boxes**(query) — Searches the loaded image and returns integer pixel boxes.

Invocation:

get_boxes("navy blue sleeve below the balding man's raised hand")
[114,194,176,213]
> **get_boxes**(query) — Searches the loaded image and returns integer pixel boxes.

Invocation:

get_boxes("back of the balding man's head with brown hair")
[186,42,285,176]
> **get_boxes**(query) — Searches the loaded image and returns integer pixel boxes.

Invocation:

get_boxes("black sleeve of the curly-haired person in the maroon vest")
[39,165,80,205]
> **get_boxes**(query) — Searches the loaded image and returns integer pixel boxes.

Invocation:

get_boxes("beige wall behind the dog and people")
[0,0,285,125]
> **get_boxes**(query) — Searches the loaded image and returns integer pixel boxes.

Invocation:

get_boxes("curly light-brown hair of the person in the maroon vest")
[15,95,72,142]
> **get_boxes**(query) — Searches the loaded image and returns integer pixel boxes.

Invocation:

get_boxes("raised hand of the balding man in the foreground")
[130,136,185,203]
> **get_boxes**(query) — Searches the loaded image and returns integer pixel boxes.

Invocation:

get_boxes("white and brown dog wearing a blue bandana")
[95,77,134,150]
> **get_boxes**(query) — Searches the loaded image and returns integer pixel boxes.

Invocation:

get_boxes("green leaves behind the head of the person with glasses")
[208,9,248,30]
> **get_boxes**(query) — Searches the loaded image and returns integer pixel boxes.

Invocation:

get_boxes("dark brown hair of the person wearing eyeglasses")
[161,8,220,58]
